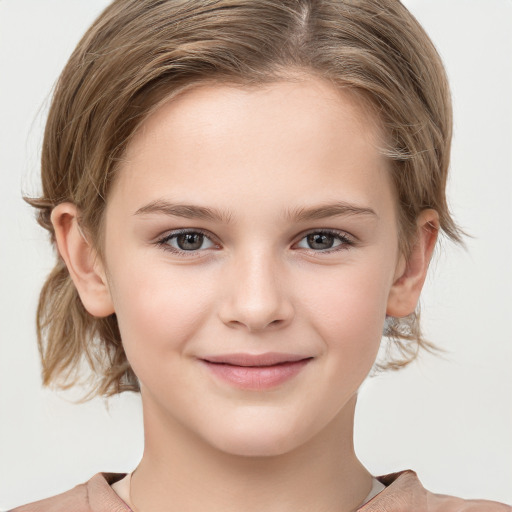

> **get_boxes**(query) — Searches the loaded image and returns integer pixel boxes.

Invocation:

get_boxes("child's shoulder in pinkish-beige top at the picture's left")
[10,473,131,512]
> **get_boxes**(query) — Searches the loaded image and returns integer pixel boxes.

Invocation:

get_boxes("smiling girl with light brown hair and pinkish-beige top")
[5,0,509,511]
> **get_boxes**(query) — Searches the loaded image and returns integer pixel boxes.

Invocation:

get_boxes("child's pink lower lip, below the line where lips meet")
[202,359,311,390]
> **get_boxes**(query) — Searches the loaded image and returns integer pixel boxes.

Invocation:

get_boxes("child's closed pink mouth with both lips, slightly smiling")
[200,352,313,391]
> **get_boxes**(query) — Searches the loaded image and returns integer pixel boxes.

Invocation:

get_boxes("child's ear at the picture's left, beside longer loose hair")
[51,203,114,317]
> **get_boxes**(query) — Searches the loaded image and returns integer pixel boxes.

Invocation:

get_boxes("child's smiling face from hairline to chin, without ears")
[104,78,404,455]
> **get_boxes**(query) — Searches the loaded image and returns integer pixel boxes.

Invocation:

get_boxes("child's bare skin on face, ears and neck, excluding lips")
[52,76,438,512]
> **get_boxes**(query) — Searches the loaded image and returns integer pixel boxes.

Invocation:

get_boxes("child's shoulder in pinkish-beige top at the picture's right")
[359,470,512,512]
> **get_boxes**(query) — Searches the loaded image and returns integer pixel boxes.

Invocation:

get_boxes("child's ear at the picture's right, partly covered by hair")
[386,210,439,318]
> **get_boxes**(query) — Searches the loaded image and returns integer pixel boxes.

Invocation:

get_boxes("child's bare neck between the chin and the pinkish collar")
[131,396,372,512]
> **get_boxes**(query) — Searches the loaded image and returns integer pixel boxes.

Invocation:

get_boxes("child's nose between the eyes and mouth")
[219,253,294,332]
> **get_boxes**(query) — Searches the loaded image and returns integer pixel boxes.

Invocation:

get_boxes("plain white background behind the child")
[0,0,512,509]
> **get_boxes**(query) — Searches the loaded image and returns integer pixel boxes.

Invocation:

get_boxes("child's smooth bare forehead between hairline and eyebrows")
[113,77,390,222]
